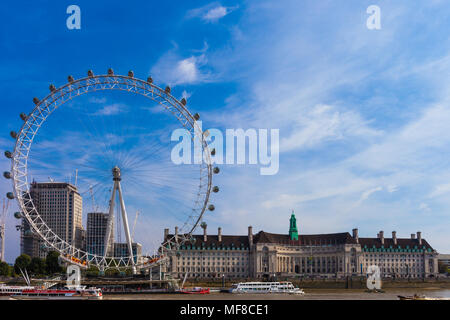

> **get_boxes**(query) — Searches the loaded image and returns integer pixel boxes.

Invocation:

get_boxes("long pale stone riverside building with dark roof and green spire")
[164,213,438,279]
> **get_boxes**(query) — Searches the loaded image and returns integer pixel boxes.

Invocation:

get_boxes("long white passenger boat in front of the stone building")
[230,281,305,294]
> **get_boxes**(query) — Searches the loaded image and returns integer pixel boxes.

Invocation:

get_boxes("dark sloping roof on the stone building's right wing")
[359,238,434,252]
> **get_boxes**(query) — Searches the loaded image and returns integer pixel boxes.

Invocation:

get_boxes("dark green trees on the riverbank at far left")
[0,251,64,277]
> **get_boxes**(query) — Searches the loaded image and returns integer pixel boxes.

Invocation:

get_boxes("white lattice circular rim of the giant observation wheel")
[11,70,212,269]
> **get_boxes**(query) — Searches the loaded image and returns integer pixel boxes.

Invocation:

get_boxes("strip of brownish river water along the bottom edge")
[103,288,450,300]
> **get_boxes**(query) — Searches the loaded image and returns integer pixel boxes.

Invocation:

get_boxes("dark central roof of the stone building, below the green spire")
[254,231,356,246]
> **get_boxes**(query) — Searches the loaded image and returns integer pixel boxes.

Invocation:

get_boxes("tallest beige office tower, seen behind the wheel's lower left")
[21,181,85,258]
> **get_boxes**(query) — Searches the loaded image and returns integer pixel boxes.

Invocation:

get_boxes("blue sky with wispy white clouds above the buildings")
[0,0,450,262]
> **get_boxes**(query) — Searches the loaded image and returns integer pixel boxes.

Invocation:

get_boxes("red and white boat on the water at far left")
[11,286,103,300]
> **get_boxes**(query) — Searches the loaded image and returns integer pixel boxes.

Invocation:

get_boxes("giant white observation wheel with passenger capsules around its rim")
[4,69,219,273]
